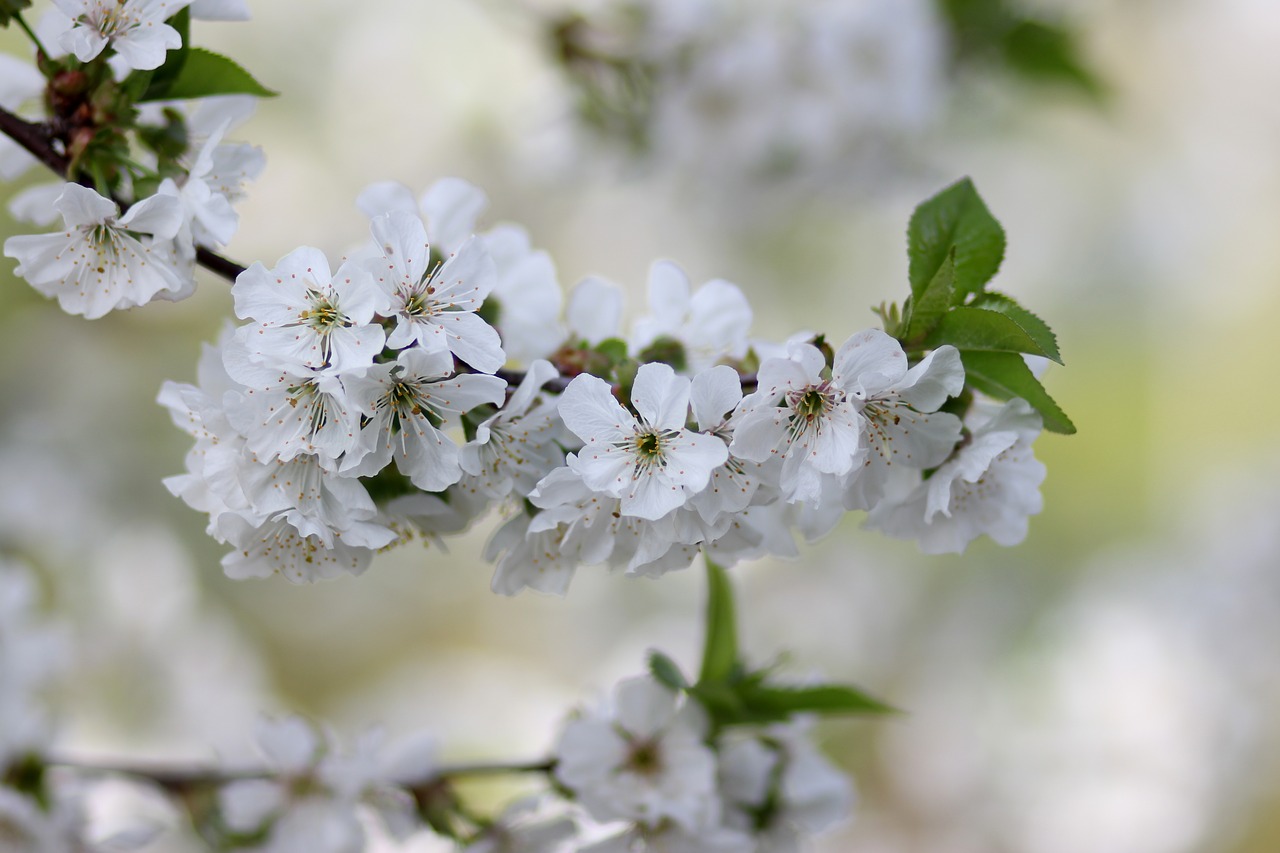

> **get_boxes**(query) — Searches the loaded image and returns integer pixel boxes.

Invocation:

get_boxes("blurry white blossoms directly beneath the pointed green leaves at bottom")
[556,676,854,853]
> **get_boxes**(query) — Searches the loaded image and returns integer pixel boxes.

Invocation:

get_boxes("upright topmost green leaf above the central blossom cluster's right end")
[908,178,1005,304]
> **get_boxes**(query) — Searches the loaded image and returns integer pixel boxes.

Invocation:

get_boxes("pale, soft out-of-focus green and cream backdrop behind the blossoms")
[0,0,1280,853]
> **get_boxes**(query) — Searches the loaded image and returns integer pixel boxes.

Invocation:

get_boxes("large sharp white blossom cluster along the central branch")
[160,175,1043,594]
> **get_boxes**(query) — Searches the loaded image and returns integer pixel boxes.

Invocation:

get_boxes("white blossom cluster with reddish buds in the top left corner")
[0,0,265,319]
